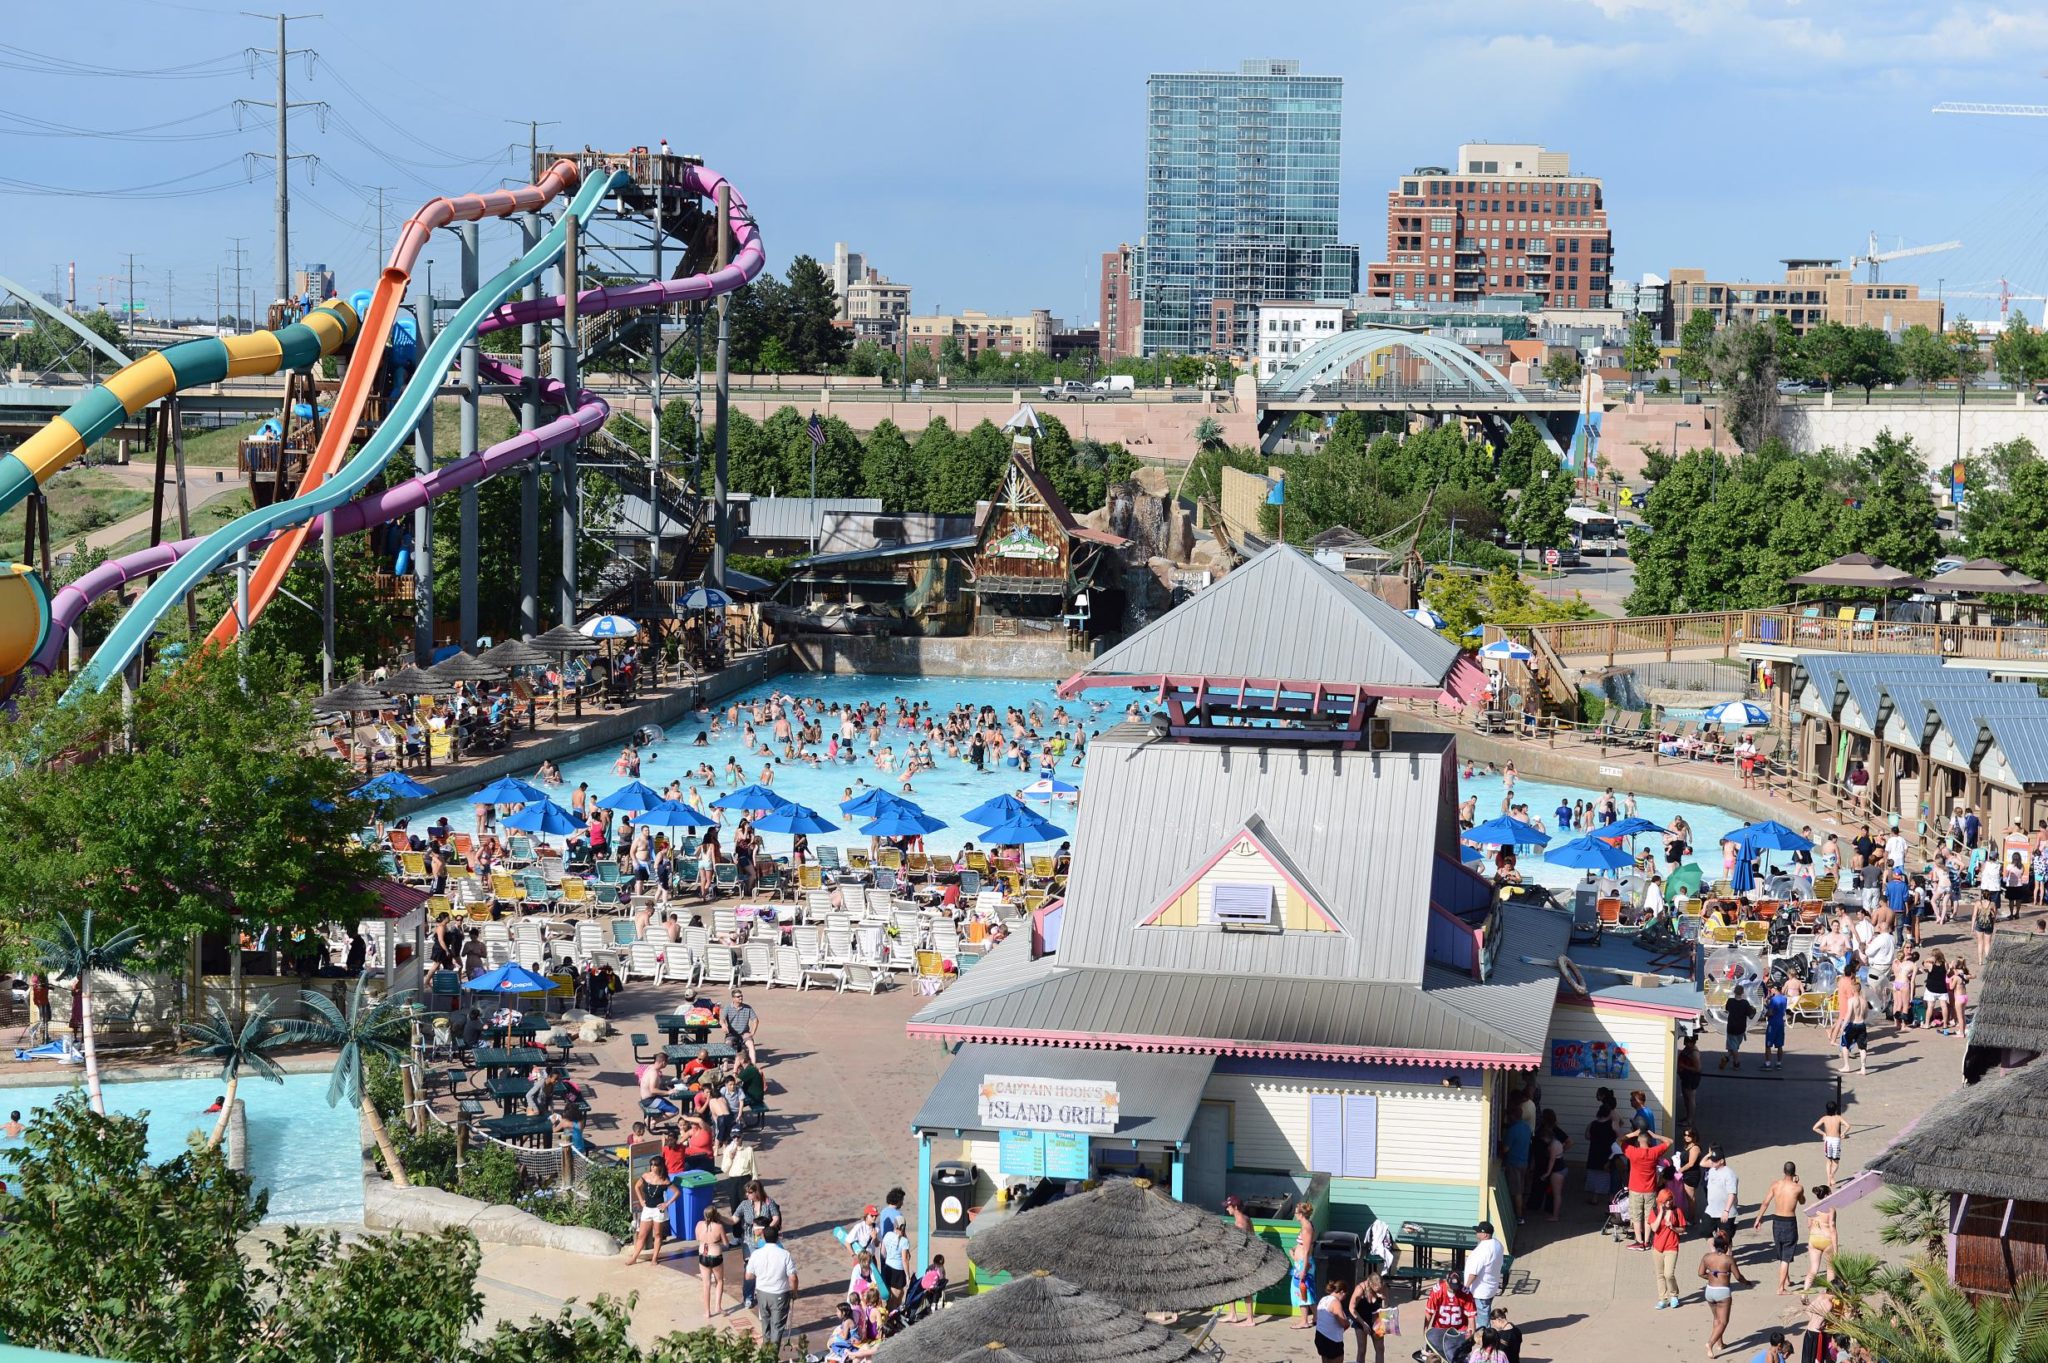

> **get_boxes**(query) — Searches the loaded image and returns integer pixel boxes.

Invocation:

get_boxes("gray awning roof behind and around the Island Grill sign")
[911,1044,1217,1142]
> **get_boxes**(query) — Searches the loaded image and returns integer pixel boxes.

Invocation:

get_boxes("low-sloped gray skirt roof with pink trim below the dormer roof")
[909,949,1556,1072]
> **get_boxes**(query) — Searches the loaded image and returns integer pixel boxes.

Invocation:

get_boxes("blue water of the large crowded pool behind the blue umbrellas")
[412,673,1743,888]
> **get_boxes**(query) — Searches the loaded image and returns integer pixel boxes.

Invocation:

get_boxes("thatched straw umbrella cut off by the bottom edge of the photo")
[874,1273,1196,1363]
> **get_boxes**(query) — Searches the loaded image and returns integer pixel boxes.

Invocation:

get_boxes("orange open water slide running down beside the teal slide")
[207,158,582,645]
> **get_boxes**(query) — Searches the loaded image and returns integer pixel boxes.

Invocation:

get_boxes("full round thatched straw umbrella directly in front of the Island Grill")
[975,1179,1288,1312]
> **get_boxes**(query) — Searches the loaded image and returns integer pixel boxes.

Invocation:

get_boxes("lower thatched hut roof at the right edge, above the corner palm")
[1870,1056,2048,1203]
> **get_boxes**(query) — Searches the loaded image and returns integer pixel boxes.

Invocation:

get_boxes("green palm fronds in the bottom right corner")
[1837,1263,2048,1363]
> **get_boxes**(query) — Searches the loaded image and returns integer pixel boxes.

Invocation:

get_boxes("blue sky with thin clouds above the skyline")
[12,0,2048,323]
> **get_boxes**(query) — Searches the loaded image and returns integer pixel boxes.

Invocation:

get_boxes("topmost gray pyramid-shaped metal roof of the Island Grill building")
[1075,544,1458,688]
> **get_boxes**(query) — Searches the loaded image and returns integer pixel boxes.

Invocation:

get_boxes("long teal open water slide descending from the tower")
[72,170,631,692]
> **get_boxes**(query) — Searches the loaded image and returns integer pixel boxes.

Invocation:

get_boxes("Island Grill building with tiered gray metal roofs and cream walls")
[907,546,1700,1310]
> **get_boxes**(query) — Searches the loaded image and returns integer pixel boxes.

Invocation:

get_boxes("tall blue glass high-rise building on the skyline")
[1141,59,1358,354]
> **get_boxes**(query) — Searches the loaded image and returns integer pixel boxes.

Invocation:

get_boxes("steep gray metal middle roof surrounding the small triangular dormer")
[1059,724,1458,984]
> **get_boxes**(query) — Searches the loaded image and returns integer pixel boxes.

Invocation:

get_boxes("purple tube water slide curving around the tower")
[29,166,766,675]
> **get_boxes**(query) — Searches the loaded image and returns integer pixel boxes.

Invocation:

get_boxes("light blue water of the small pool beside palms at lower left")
[0,1070,362,1226]
